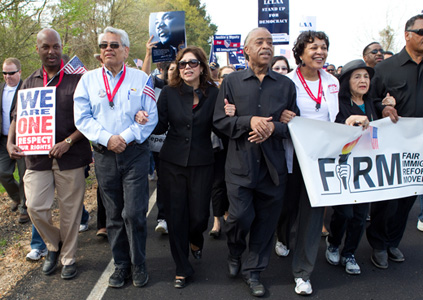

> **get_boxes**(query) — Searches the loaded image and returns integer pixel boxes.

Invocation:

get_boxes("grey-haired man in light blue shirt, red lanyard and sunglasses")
[74,27,157,288]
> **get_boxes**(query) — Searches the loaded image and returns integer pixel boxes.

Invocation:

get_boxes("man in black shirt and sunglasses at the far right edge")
[367,14,423,269]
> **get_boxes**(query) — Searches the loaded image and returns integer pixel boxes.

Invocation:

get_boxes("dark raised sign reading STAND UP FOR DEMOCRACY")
[258,0,289,45]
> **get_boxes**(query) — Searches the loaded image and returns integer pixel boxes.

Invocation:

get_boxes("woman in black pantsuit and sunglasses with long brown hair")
[154,46,219,288]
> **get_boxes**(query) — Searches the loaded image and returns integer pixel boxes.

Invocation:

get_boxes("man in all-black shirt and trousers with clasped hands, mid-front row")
[214,28,298,296]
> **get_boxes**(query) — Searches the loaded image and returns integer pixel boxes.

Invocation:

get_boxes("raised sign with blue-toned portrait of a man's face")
[149,11,186,63]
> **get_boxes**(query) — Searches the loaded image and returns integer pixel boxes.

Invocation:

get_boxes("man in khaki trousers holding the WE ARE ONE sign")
[7,28,92,279]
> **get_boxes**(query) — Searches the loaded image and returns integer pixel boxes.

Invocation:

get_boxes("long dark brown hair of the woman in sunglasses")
[169,46,216,93]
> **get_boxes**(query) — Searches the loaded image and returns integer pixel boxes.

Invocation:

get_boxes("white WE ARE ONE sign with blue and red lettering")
[16,86,56,155]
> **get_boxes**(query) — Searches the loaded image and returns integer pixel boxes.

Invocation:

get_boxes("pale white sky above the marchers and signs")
[201,0,423,67]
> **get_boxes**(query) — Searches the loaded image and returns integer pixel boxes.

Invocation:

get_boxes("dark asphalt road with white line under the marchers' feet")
[5,182,423,300]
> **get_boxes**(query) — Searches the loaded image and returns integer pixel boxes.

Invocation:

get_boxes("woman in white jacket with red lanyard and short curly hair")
[281,31,339,295]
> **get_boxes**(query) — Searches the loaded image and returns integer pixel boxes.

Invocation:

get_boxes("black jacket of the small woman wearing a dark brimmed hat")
[335,97,378,124]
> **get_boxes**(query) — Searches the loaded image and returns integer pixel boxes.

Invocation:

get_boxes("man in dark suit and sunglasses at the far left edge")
[0,58,29,223]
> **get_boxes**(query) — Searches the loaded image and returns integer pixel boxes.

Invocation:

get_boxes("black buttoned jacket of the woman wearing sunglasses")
[153,83,219,167]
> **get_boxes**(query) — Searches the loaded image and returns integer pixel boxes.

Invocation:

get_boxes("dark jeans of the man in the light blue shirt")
[94,142,149,269]
